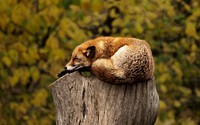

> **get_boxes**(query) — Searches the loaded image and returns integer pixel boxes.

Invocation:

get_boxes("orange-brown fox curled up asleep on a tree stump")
[58,37,154,84]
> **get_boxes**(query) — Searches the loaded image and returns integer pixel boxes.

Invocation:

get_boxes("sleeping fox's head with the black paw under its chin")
[58,46,95,77]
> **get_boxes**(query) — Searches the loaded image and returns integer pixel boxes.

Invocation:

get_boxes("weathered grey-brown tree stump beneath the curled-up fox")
[50,72,159,125]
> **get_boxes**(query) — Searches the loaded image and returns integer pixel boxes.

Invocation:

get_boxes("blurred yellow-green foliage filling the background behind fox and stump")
[0,0,200,125]
